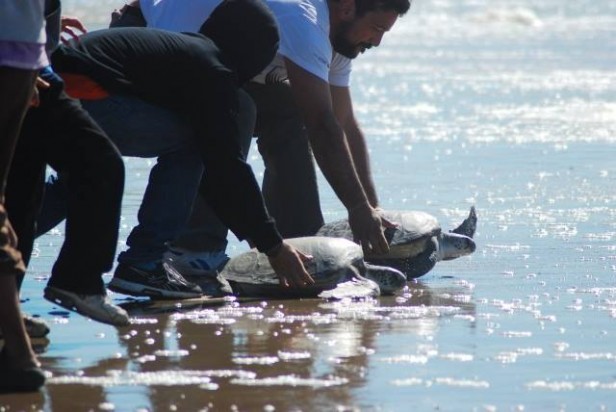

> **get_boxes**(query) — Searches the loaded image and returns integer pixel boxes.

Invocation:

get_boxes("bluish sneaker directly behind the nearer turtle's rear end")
[163,248,229,276]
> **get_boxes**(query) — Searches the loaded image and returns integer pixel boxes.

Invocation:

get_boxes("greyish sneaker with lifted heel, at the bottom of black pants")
[44,286,130,326]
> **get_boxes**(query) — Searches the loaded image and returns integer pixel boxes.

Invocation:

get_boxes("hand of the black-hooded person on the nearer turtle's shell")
[268,242,314,288]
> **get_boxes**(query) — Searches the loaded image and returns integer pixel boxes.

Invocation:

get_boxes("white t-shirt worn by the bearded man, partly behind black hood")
[140,0,351,87]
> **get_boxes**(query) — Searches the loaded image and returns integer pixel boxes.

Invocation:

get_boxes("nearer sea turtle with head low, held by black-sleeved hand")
[183,236,406,298]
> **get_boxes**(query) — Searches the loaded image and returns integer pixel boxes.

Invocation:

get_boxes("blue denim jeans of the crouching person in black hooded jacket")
[39,93,254,264]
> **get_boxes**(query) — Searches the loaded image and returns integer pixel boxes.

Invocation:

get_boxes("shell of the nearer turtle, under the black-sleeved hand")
[219,237,370,298]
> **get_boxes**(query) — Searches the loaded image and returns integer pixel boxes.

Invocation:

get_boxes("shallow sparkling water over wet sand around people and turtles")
[0,0,616,411]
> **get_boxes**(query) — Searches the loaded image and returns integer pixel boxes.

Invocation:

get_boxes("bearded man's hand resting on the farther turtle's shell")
[349,202,397,255]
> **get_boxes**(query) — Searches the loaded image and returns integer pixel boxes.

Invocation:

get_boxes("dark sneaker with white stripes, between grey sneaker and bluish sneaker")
[107,263,202,299]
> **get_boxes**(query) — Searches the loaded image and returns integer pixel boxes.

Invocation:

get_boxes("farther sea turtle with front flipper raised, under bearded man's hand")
[317,206,477,279]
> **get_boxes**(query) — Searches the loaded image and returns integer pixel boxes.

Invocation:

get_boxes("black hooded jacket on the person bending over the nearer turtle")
[52,0,282,252]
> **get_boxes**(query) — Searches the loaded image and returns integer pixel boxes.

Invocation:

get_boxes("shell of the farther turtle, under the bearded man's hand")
[317,211,441,260]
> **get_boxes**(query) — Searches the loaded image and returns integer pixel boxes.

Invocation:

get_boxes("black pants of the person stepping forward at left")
[6,77,124,294]
